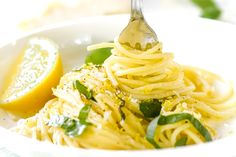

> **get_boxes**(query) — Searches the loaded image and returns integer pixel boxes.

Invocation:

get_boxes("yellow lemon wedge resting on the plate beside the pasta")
[0,38,63,116]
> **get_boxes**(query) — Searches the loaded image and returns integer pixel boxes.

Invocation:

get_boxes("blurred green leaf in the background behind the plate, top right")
[192,0,221,19]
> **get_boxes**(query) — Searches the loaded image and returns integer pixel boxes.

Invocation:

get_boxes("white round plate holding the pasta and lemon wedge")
[0,14,236,157]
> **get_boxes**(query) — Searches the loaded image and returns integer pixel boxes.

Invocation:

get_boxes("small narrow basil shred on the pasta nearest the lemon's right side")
[73,80,94,99]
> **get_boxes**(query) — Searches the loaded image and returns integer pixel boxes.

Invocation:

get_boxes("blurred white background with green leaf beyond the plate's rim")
[0,0,236,45]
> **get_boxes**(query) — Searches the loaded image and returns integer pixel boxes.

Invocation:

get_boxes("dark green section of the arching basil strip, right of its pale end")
[158,113,212,141]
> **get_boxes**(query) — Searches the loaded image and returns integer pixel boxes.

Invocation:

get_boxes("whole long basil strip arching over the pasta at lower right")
[146,113,212,149]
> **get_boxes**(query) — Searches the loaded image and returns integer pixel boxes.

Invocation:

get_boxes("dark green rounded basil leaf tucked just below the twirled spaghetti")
[139,99,162,118]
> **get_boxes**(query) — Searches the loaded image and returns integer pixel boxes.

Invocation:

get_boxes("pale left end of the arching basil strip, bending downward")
[146,117,161,149]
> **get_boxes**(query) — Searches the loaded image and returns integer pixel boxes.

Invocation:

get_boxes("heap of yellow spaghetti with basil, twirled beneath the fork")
[12,40,236,150]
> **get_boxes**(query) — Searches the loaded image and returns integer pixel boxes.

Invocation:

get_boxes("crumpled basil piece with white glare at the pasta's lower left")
[47,105,91,137]
